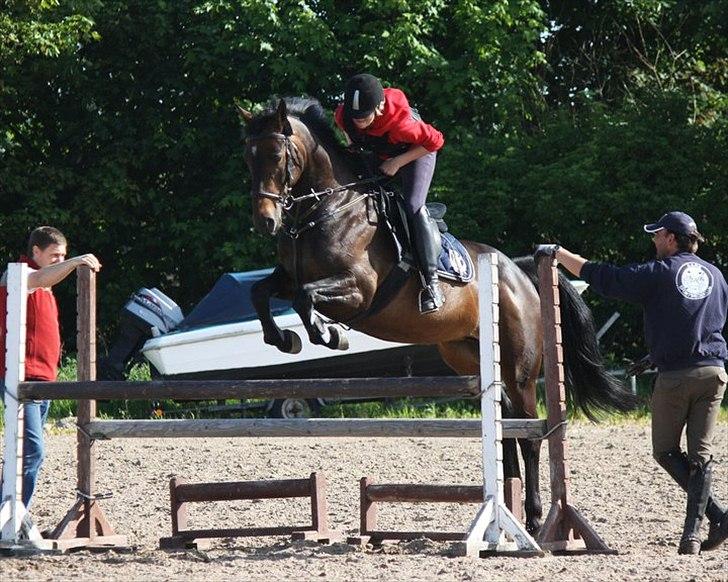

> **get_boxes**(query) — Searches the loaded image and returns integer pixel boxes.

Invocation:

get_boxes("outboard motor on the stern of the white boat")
[97,287,184,380]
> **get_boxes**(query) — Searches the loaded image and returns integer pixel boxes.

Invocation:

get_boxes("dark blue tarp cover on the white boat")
[178,269,291,330]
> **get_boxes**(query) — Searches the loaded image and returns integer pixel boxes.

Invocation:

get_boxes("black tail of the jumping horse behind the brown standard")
[514,257,637,420]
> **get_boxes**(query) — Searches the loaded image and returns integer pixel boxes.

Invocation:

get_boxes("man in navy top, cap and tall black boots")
[534,212,728,554]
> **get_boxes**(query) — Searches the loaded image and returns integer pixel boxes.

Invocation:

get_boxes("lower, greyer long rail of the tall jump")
[83,418,546,439]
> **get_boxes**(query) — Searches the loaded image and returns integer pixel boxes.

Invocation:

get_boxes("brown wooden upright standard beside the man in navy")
[538,257,617,554]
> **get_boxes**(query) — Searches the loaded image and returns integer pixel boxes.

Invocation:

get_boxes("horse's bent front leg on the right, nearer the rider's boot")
[293,275,364,350]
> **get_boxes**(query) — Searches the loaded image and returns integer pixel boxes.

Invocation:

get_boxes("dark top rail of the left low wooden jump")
[175,479,311,502]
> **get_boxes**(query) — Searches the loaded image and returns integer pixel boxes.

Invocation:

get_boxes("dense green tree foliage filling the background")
[0,0,728,364]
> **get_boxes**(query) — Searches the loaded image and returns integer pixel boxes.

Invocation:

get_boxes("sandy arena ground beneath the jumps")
[0,423,728,581]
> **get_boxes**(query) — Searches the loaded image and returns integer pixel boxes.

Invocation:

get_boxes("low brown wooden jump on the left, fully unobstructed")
[159,473,341,550]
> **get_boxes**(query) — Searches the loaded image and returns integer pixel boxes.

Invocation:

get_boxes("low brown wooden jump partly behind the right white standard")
[346,477,523,546]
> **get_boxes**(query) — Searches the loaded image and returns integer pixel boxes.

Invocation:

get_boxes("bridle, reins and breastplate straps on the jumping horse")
[246,132,389,239]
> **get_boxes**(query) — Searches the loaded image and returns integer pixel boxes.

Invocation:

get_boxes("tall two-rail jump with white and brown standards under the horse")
[0,254,612,555]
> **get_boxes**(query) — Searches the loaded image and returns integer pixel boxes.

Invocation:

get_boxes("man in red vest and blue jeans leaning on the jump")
[0,226,101,508]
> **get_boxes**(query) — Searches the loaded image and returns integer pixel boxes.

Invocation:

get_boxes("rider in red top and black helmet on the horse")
[334,74,445,313]
